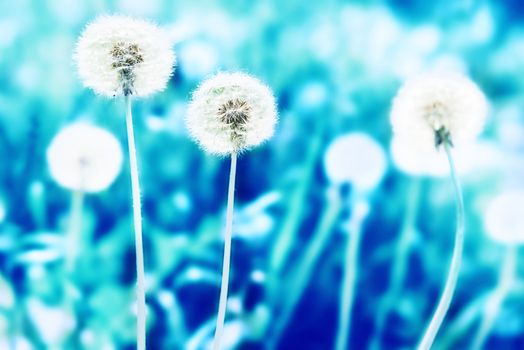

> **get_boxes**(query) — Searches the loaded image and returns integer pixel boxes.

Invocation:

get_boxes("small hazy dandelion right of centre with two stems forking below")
[269,132,386,349]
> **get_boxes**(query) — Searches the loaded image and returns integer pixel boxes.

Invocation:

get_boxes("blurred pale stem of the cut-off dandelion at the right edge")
[472,247,517,349]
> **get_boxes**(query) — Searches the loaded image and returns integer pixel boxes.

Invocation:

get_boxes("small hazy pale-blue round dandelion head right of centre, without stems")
[324,132,387,191]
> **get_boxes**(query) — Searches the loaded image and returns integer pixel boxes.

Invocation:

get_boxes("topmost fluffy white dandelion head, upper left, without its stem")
[74,16,175,97]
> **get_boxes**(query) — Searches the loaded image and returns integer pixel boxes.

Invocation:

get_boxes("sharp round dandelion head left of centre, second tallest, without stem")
[186,73,277,155]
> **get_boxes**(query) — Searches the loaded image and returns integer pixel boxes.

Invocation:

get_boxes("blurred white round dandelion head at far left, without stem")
[47,123,123,192]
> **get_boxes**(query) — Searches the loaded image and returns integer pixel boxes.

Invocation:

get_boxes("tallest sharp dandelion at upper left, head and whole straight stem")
[74,16,175,350]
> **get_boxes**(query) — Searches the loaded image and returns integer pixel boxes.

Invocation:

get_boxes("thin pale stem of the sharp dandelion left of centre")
[213,152,237,350]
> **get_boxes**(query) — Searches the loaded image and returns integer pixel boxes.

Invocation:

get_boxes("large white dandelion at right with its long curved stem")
[391,74,488,349]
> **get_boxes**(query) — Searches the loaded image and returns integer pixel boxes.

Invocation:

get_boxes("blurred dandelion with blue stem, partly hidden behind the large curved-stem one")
[380,137,502,350]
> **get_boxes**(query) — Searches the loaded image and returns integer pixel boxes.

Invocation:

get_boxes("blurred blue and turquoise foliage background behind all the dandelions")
[0,0,524,350]
